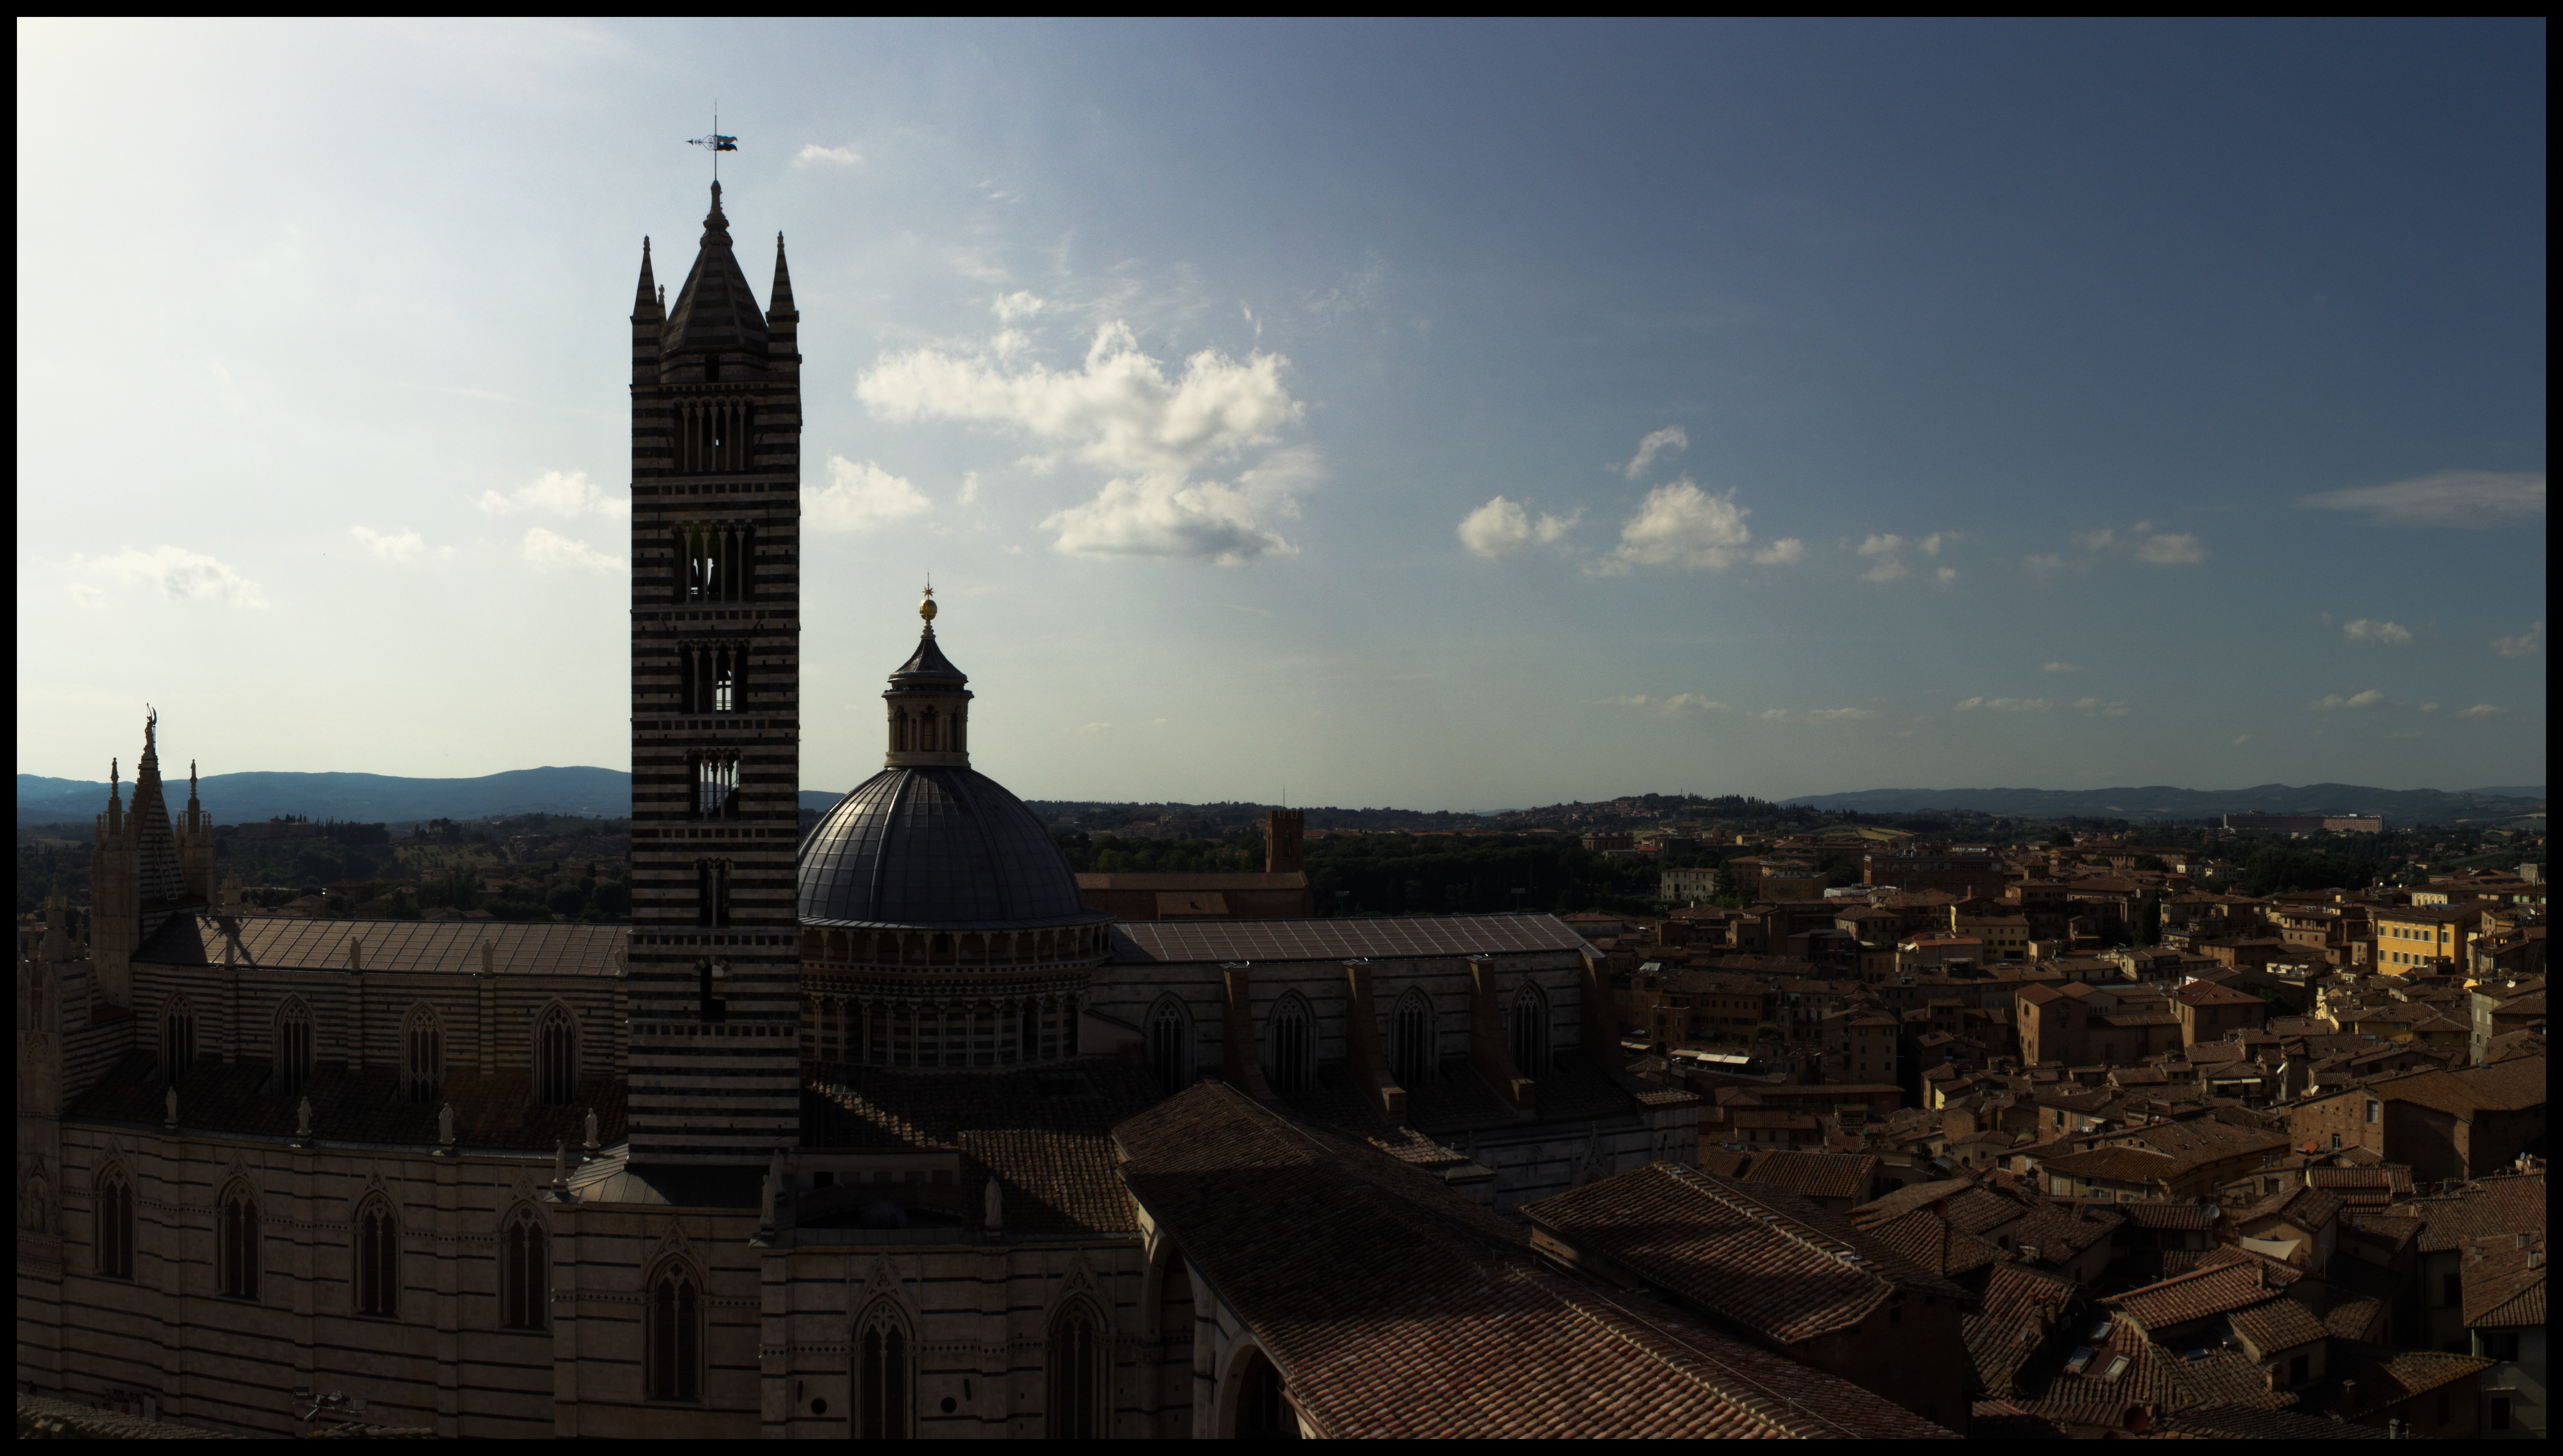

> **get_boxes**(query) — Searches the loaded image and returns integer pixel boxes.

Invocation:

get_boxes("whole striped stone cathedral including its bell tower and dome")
[18,185,1866,1438]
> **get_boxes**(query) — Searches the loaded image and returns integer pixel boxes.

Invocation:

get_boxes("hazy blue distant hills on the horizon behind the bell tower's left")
[18,769,846,823]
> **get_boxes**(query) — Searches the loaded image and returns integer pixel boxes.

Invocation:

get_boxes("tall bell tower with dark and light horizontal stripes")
[631,182,802,1166]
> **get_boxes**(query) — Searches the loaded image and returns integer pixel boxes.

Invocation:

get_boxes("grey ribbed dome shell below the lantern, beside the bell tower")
[800,769,1105,925]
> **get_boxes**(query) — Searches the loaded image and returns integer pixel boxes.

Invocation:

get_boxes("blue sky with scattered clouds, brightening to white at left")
[18,23,2545,807]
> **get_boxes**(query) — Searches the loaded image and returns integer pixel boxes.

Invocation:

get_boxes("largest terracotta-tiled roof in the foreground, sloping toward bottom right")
[1115,1082,1948,1438]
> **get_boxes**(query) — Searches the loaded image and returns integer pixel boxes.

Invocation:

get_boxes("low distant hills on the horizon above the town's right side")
[1781,784,2545,825]
